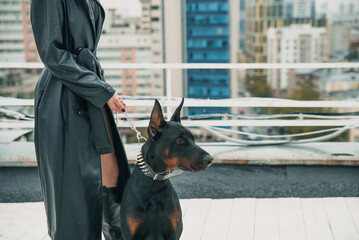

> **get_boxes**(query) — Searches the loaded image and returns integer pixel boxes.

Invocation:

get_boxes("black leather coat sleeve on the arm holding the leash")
[31,0,115,108]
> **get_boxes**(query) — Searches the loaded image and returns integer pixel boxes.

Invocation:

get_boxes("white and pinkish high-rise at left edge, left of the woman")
[0,0,40,98]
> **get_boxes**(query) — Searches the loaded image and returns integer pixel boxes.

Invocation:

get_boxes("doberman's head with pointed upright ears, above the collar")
[147,98,213,172]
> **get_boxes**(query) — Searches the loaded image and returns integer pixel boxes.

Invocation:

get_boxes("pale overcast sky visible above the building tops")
[100,0,359,17]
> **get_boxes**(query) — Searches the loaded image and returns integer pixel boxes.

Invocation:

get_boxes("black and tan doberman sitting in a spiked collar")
[120,99,213,240]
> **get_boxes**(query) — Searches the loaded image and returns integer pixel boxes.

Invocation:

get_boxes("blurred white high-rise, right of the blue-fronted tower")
[267,24,330,97]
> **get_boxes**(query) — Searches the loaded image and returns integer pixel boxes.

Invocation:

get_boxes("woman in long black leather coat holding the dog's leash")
[31,0,129,240]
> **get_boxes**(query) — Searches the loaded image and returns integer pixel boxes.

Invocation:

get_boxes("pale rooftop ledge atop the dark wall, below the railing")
[0,142,359,167]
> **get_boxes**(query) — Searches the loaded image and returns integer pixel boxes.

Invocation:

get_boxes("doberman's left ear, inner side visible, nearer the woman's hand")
[147,100,166,140]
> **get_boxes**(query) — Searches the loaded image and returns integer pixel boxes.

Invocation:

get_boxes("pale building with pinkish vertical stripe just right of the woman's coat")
[97,11,163,112]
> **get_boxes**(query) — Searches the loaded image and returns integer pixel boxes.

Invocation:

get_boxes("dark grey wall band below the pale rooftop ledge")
[0,165,359,202]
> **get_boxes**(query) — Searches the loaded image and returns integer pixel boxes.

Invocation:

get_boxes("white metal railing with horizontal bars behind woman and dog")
[0,63,359,144]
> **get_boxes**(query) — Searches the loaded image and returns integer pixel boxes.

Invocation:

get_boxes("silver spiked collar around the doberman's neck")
[137,151,184,181]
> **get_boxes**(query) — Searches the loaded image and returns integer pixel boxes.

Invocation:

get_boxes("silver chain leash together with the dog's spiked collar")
[116,109,184,181]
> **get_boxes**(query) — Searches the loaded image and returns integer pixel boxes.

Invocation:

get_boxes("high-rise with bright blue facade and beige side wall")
[164,0,239,115]
